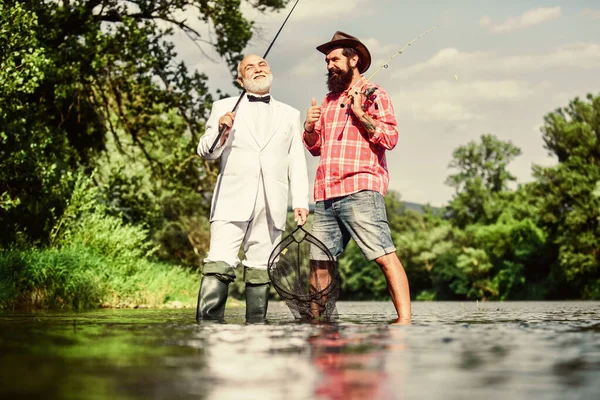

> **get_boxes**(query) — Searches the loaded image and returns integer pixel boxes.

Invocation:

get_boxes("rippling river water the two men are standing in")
[0,302,600,400]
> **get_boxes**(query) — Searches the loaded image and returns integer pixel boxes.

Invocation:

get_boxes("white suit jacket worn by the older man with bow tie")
[198,95,308,230]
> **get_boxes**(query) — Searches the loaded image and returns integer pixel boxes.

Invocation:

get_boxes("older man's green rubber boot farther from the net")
[196,261,235,321]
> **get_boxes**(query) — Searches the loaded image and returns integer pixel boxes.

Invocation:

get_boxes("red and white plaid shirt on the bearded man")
[303,77,398,201]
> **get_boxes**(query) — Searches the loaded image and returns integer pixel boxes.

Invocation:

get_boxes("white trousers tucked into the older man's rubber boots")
[204,179,283,270]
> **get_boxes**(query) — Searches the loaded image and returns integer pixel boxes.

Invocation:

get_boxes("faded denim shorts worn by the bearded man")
[310,190,396,260]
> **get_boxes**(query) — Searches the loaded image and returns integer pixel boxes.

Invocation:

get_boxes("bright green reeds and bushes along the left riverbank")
[0,173,199,309]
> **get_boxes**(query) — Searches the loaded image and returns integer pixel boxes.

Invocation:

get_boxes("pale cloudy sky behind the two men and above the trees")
[168,0,600,206]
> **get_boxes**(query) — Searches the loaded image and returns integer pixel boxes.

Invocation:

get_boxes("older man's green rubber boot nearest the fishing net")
[244,267,270,322]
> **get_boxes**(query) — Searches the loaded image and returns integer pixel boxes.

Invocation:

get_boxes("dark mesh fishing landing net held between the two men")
[267,226,340,321]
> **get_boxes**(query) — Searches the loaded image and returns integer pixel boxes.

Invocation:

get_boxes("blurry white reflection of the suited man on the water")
[195,318,315,399]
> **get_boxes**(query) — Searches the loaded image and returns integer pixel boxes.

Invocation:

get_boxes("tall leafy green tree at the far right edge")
[534,94,600,299]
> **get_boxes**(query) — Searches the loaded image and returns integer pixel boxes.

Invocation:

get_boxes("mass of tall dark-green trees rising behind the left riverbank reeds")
[0,0,288,261]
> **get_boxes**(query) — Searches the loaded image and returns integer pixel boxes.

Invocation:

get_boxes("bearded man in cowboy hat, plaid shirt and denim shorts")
[303,31,411,322]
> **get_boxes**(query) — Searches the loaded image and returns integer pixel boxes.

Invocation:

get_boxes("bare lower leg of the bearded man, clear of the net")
[375,253,412,321]
